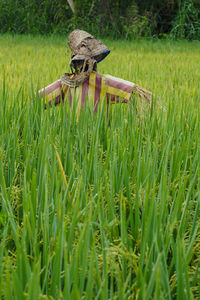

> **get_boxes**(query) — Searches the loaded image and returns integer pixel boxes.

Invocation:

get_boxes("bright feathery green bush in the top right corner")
[170,0,200,40]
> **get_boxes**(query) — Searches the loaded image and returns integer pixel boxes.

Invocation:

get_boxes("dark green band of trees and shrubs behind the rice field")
[0,0,200,39]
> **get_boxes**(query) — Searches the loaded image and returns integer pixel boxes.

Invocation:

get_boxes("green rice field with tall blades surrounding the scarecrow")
[0,35,200,300]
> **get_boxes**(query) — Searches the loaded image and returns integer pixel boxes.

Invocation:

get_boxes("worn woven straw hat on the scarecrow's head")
[68,29,110,71]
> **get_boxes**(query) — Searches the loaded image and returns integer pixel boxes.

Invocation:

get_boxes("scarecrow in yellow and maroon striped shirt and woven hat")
[39,29,155,114]
